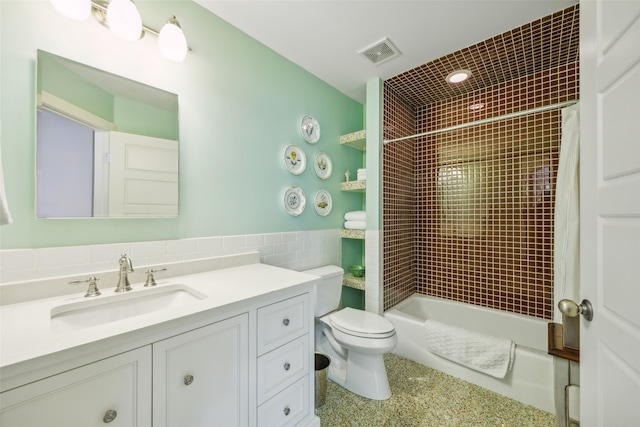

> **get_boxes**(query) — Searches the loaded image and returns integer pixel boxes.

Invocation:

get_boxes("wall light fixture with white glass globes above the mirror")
[51,0,191,62]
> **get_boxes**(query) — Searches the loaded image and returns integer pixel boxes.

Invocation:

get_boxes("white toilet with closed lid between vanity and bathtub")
[304,265,398,400]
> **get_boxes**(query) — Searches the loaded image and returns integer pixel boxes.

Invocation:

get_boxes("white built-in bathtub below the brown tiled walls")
[384,294,555,413]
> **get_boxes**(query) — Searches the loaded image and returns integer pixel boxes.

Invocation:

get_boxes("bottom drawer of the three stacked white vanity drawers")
[258,376,310,427]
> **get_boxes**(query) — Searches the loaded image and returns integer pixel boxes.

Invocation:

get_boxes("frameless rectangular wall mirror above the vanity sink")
[36,50,179,218]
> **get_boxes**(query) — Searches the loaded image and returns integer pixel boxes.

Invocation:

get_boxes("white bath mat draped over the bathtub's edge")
[424,320,515,378]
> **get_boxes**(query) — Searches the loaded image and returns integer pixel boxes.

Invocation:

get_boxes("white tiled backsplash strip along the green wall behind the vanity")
[0,229,342,284]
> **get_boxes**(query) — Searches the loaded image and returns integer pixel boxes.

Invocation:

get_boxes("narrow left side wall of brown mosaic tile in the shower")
[383,89,417,308]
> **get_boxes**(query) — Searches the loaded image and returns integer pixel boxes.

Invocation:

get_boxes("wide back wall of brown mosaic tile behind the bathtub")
[416,64,578,319]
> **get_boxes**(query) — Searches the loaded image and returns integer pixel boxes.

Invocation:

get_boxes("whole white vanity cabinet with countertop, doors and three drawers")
[0,263,319,427]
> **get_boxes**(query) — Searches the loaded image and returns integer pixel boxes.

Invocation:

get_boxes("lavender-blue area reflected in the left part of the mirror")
[36,110,94,218]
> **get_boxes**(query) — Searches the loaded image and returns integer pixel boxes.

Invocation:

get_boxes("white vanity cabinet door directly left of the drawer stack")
[153,314,249,427]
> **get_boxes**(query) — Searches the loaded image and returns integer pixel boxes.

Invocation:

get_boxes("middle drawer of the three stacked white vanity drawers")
[257,335,309,404]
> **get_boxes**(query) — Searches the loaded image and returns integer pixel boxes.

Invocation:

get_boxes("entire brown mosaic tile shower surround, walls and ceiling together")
[383,5,579,319]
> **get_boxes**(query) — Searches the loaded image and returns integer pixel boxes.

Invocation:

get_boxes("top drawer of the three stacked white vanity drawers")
[258,294,310,355]
